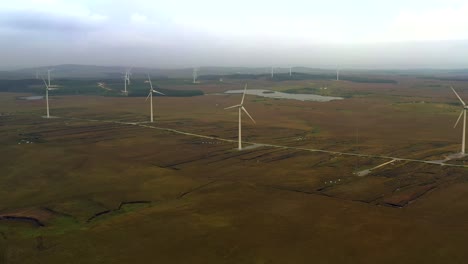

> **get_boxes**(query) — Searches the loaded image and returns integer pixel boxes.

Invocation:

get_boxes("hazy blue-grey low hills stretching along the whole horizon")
[0,64,468,80]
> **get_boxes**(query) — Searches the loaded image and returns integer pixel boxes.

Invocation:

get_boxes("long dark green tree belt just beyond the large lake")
[198,72,397,84]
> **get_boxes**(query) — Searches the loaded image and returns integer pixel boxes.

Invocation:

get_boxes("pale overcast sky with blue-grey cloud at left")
[0,0,468,69]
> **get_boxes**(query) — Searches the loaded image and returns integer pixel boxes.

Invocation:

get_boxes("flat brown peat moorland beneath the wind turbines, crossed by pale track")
[0,77,468,263]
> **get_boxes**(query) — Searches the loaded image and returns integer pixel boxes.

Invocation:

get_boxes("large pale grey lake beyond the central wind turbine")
[225,89,344,102]
